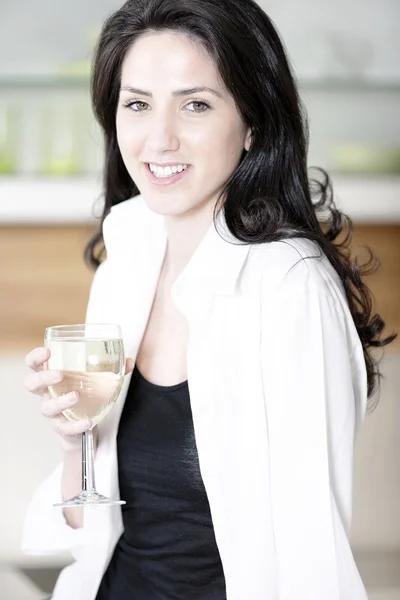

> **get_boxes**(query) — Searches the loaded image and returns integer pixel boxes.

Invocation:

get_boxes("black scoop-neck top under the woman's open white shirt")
[96,368,226,600]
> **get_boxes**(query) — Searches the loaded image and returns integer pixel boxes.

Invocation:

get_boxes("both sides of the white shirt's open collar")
[103,195,250,294]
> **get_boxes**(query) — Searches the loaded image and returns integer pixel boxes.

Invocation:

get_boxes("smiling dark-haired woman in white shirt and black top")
[24,0,394,600]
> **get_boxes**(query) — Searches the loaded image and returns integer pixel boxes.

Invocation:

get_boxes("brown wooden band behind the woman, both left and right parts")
[0,225,400,354]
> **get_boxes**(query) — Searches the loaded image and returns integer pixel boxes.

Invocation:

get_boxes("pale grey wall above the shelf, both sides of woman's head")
[0,0,400,79]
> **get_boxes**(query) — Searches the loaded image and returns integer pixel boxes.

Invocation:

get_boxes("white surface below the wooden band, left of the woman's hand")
[0,356,61,564]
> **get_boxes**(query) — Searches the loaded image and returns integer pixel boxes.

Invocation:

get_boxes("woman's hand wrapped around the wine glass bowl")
[25,348,134,450]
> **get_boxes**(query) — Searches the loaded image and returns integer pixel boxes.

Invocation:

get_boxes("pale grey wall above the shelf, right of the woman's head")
[259,0,400,80]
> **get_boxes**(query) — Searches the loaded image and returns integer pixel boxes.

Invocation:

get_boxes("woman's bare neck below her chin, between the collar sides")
[164,199,214,280]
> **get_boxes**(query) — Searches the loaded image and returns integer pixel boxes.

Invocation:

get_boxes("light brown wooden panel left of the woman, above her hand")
[0,226,93,354]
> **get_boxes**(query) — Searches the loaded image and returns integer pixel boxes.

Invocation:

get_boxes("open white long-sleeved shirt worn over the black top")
[23,196,367,600]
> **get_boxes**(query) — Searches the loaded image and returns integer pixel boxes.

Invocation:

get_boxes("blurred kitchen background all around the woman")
[0,0,400,600]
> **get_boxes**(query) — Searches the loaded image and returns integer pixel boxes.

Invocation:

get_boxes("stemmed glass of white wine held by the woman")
[44,323,125,508]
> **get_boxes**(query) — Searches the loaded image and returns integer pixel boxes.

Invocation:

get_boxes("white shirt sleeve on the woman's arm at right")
[261,261,367,600]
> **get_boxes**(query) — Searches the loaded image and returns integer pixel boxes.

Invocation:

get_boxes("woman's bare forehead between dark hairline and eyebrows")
[121,31,224,89]
